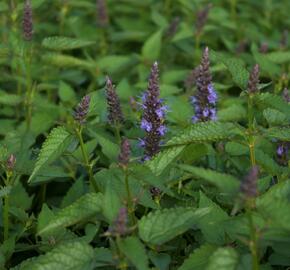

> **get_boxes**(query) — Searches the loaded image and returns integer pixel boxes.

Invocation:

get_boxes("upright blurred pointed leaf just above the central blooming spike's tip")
[142,31,162,61]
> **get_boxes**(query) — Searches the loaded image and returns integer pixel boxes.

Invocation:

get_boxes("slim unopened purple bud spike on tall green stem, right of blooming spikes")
[248,64,260,166]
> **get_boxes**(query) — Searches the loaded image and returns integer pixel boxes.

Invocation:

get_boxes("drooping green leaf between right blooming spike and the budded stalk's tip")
[211,51,249,90]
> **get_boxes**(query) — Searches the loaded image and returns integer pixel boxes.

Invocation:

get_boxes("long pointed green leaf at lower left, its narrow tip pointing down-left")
[38,193,103,235]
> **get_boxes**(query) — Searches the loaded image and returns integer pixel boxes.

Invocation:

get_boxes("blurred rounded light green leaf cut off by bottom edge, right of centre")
[205,247,239,270]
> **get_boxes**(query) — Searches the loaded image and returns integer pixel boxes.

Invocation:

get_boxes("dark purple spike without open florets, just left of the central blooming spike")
[106,76,124,125]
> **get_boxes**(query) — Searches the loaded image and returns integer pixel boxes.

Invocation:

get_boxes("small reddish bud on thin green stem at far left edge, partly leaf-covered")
[3,155,16,241]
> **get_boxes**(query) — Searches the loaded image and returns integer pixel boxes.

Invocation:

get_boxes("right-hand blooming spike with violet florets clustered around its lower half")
[191,47,217,123]
